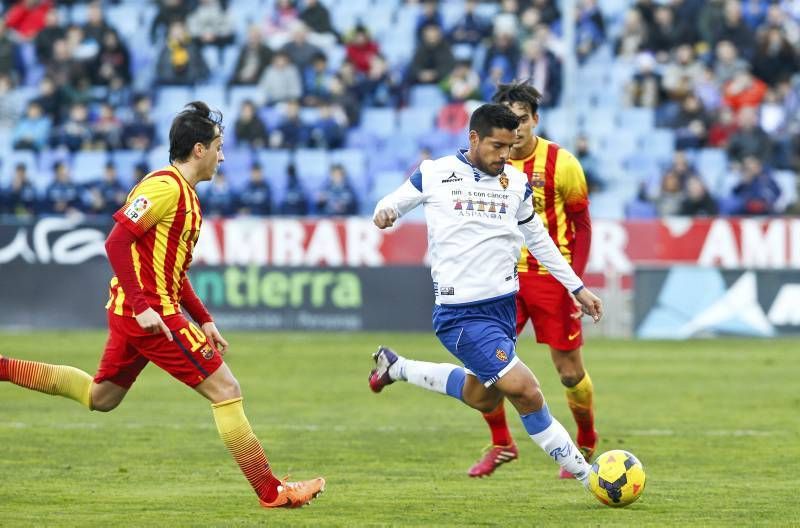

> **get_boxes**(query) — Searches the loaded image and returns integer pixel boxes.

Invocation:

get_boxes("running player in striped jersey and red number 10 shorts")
[0,101,325,508]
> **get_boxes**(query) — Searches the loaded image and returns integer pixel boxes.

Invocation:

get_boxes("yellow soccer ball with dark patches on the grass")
[589,449,645,508]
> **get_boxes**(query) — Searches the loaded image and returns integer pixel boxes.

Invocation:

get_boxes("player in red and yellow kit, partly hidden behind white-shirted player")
[469,83,597,478]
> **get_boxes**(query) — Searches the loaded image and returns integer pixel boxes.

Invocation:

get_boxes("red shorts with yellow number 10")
[94,312,222,389]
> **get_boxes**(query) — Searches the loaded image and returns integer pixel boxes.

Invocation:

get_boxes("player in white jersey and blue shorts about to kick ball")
[369,104,603,485]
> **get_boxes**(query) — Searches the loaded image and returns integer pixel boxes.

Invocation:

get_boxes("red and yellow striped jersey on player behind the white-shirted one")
[509,138,589,274]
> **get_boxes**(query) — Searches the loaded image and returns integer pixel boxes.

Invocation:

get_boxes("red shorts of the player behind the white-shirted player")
[517,272,583,350]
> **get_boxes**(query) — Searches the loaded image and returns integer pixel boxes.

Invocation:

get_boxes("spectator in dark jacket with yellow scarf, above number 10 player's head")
[156,22,209,85]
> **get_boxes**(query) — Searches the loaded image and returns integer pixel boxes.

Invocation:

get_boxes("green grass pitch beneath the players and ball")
[0,332,800,528]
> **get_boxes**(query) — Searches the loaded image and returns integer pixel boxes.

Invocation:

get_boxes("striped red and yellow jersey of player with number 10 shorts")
[106,165,203,317]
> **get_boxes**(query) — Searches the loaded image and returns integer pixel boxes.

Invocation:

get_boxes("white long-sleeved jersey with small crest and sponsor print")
[375,150,583,306]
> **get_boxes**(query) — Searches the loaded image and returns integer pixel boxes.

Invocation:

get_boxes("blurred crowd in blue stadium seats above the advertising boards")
[0,0,800,217]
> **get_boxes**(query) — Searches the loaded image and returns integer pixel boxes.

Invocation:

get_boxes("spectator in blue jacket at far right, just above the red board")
[726,155,781,215]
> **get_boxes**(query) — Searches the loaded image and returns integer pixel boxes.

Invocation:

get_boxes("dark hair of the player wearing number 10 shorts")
[169,101,223,163]
